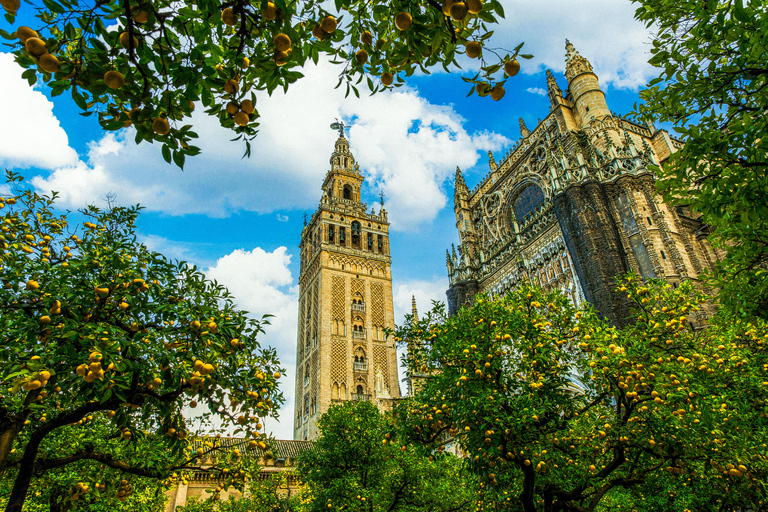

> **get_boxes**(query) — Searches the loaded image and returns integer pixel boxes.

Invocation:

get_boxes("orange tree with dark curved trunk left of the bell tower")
[0,173,282,512]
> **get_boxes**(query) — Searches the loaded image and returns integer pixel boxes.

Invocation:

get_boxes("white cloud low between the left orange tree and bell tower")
[205,247,298,439]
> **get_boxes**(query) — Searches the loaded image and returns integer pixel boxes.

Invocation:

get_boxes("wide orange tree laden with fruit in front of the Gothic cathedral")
[397,276,768,512]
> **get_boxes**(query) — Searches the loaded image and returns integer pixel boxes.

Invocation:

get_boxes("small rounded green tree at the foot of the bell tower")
[297,401,474,512]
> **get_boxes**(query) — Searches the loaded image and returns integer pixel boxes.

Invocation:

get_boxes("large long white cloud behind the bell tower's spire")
[33,57,509,229]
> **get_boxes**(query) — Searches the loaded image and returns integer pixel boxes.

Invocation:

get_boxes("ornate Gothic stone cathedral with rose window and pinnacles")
[447,40,714,325]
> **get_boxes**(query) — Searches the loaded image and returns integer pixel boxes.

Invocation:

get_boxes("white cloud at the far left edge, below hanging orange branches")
[0,53,77,169]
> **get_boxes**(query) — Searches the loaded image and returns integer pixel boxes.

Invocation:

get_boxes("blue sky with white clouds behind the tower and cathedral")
[0,0,653,438]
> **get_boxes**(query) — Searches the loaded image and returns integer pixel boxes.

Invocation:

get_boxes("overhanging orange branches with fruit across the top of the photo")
[0,0,530,166]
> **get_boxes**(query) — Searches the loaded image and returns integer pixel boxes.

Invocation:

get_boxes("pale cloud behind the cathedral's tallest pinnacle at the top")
[500,0,658,90]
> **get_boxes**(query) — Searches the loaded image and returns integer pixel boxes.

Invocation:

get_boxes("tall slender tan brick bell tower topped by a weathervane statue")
[293,125,400,440]
